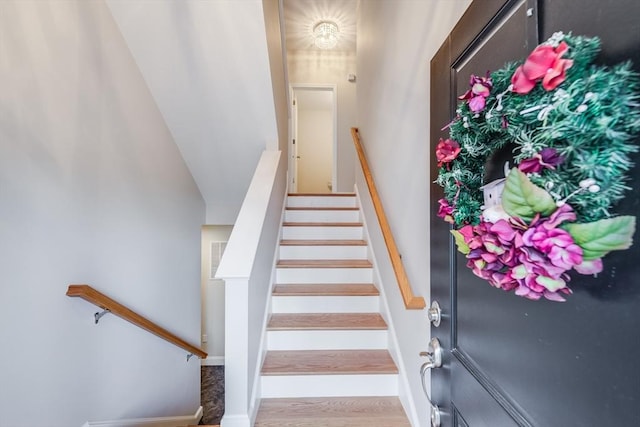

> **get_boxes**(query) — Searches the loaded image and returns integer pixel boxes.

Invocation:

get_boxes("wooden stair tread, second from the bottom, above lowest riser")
[262,350,398,375]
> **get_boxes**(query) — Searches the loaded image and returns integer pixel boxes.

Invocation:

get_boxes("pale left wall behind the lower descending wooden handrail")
[0,0,205,427]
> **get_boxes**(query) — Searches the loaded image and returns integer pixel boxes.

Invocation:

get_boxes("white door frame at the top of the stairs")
[288,83,338,193]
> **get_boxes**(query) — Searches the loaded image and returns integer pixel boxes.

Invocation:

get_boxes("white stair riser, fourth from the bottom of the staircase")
[276,268,373,284]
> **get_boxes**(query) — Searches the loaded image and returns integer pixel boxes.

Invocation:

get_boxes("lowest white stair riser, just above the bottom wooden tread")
[261,374,398,398]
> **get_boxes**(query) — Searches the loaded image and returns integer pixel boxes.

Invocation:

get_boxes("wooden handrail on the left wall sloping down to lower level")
[67,285,207,359]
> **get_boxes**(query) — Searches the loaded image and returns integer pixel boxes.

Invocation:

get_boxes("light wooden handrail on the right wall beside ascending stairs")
[351,128,426,310]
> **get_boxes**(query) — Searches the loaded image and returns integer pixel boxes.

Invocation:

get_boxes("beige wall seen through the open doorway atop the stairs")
[296,108,333,193]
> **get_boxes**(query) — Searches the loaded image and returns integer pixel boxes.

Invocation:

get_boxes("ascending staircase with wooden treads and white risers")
[255,193,411,427]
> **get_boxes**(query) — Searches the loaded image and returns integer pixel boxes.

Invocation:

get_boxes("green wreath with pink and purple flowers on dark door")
[435,33,640,301]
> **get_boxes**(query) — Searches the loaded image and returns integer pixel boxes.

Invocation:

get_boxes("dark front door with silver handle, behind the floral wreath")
[431,0,640,427]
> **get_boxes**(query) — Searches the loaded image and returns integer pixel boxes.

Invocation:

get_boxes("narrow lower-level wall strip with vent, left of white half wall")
[201,225,233,365]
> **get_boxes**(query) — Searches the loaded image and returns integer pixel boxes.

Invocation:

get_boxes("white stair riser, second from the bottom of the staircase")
[267,330,388,350]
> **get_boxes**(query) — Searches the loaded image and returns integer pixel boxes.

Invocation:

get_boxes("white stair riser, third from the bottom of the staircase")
[271,295,380,313]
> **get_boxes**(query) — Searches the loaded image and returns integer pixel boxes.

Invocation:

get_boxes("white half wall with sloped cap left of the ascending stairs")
[216,151,286,427]
